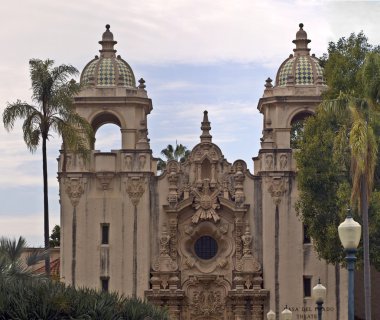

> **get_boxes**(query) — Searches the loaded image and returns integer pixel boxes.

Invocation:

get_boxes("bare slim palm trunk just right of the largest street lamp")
[360,173,372,320]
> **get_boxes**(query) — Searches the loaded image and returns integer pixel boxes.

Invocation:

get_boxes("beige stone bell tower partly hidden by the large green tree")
[254,23,346,319]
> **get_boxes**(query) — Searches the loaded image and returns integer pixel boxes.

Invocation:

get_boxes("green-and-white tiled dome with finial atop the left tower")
[80,24,136,87]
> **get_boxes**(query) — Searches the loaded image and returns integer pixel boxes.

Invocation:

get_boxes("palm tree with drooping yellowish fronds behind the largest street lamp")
[322,52,380,319]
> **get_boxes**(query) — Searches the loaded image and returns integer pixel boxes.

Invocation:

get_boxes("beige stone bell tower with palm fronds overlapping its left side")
[58,25,157,296]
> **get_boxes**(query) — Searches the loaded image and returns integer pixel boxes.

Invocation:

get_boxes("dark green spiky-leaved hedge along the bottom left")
[0,277,168,320]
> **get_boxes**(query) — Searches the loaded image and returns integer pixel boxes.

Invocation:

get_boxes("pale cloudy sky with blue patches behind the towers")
[0,0,380,247]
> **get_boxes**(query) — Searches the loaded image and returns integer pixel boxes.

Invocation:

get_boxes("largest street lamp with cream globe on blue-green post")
[338,209,362,320]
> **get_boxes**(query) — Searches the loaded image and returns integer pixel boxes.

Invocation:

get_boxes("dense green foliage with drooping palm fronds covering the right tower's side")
[296,33,380,269]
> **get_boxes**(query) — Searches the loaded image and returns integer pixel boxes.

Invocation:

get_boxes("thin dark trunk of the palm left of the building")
[42,136,50,276]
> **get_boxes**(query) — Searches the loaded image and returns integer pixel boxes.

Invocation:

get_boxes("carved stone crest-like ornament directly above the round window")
[191,179,220,223]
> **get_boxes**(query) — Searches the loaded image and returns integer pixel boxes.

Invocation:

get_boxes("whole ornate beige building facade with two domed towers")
[59,25,347,320]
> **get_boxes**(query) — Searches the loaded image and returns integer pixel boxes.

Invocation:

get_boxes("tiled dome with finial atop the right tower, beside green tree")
[276,23,326,86]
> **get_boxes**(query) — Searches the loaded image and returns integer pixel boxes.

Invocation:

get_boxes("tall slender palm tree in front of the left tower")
[3,59,93,275]
